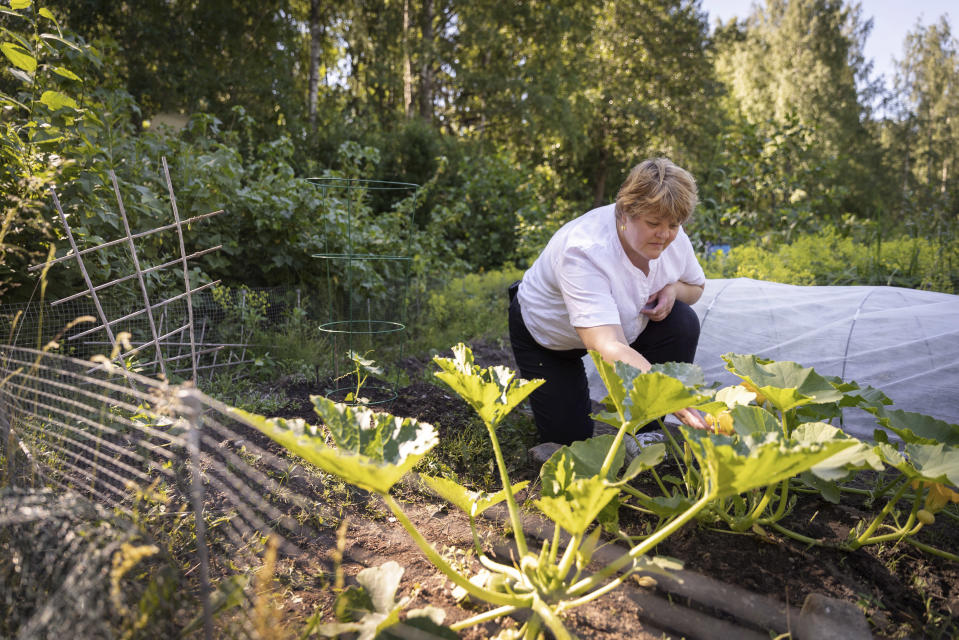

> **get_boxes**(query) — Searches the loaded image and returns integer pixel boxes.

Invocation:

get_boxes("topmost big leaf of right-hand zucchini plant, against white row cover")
[723,353,843,411]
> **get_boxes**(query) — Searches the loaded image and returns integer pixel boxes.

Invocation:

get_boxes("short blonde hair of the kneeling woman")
[616,158,699,224]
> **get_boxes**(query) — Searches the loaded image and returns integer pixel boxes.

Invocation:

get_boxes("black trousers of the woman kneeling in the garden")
[509,290,699,444]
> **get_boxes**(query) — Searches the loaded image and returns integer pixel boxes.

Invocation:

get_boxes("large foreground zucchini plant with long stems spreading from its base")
[237,344,854,640]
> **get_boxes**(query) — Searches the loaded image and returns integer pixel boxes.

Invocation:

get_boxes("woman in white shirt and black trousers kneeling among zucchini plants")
[509,158,707,444]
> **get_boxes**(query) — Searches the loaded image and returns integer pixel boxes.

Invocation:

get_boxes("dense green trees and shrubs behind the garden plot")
[0,0,959,302]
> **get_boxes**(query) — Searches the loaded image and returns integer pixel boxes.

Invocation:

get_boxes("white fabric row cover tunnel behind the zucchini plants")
[587,278,959,438]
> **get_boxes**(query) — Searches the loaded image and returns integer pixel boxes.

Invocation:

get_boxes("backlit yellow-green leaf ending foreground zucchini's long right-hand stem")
[680,427,854,498]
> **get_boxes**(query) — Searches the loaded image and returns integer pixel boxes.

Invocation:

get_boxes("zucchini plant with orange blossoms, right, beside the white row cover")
[628,354,959,560]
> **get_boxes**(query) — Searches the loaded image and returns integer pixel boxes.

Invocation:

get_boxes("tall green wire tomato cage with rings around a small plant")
[307,177,419,405]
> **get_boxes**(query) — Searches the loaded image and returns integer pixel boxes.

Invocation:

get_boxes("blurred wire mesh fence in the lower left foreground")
[0,346,344,638]
